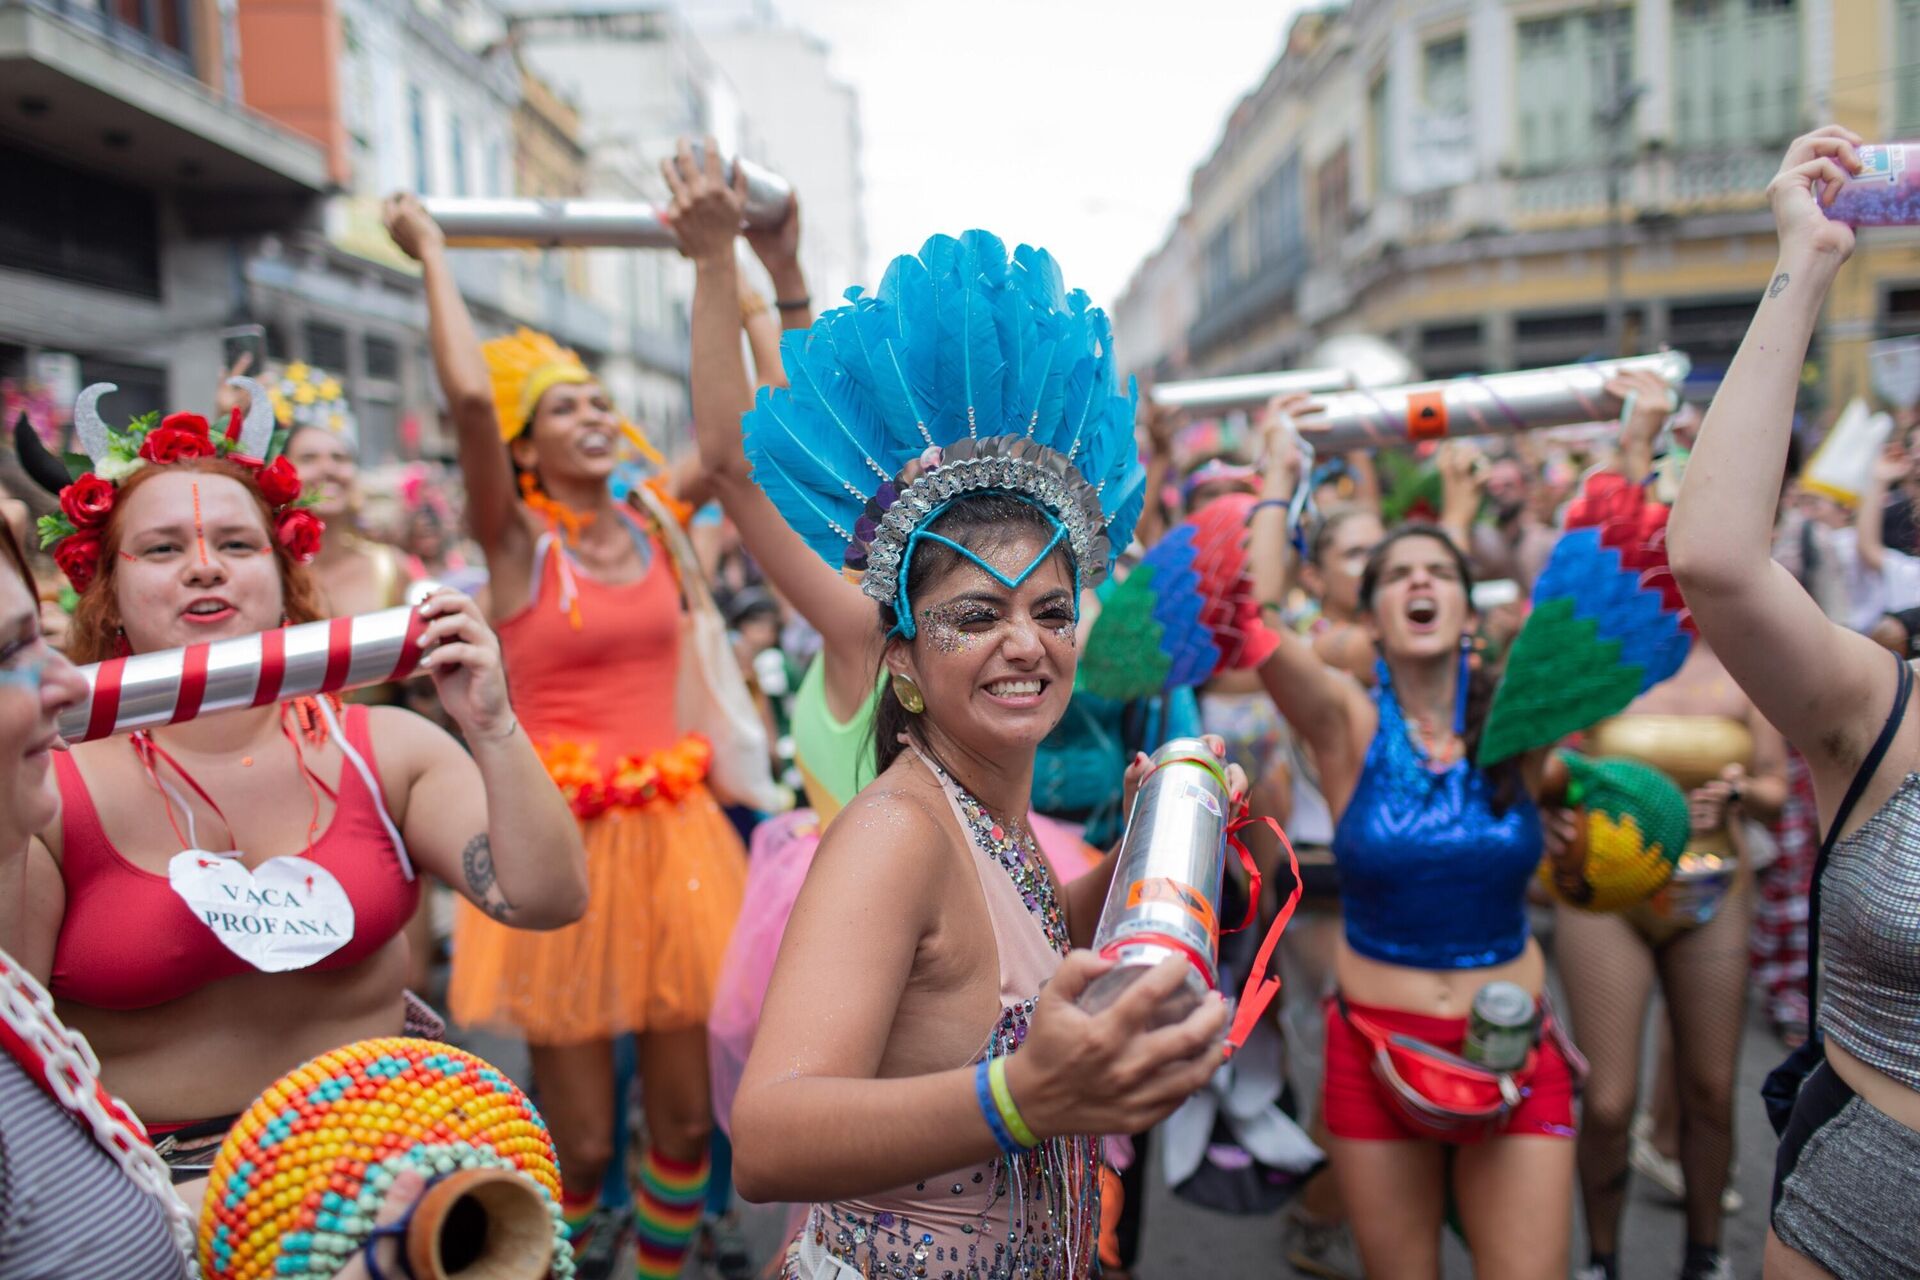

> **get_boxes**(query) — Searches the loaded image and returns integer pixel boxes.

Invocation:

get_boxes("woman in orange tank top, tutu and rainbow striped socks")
[386,196,772,1276]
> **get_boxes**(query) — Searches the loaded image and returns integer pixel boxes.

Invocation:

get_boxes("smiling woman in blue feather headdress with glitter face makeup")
[674,147,1244,1278]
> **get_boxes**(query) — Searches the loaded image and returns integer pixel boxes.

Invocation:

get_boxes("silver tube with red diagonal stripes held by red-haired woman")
[60,604,426,743]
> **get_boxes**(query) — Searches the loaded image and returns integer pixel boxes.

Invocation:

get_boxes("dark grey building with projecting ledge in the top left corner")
[0,0,330,426]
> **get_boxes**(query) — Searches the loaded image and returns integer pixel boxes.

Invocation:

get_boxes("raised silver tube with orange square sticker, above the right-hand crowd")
[1308,351,1692,455]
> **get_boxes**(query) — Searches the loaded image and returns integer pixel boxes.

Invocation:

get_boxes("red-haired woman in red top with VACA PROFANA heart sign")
[0,386,586,1176]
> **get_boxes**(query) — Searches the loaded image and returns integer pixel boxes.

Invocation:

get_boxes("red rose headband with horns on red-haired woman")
[28,378,326,591]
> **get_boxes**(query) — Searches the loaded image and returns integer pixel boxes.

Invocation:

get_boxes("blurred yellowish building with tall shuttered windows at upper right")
[1119,0,1920,408]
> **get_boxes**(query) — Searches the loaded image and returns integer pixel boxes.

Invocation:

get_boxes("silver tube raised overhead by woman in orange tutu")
[422,159,793,249]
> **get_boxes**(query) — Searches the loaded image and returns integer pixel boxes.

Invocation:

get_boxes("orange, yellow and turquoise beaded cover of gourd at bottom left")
[200,1036,574,1280]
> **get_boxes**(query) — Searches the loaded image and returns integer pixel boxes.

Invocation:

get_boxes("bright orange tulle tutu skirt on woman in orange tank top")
[447,787,747,1044]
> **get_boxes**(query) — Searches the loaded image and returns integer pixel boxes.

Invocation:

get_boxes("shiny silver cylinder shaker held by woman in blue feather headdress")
[1081,737,1231,1027]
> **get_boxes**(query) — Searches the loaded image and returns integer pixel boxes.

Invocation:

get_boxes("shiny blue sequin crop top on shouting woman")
[1332,662,1542,969]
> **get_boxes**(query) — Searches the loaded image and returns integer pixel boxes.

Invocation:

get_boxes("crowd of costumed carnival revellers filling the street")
[0,119,1920,1280]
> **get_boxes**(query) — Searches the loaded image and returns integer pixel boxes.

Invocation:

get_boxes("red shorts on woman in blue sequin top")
[1321,1000,1574,1142]
